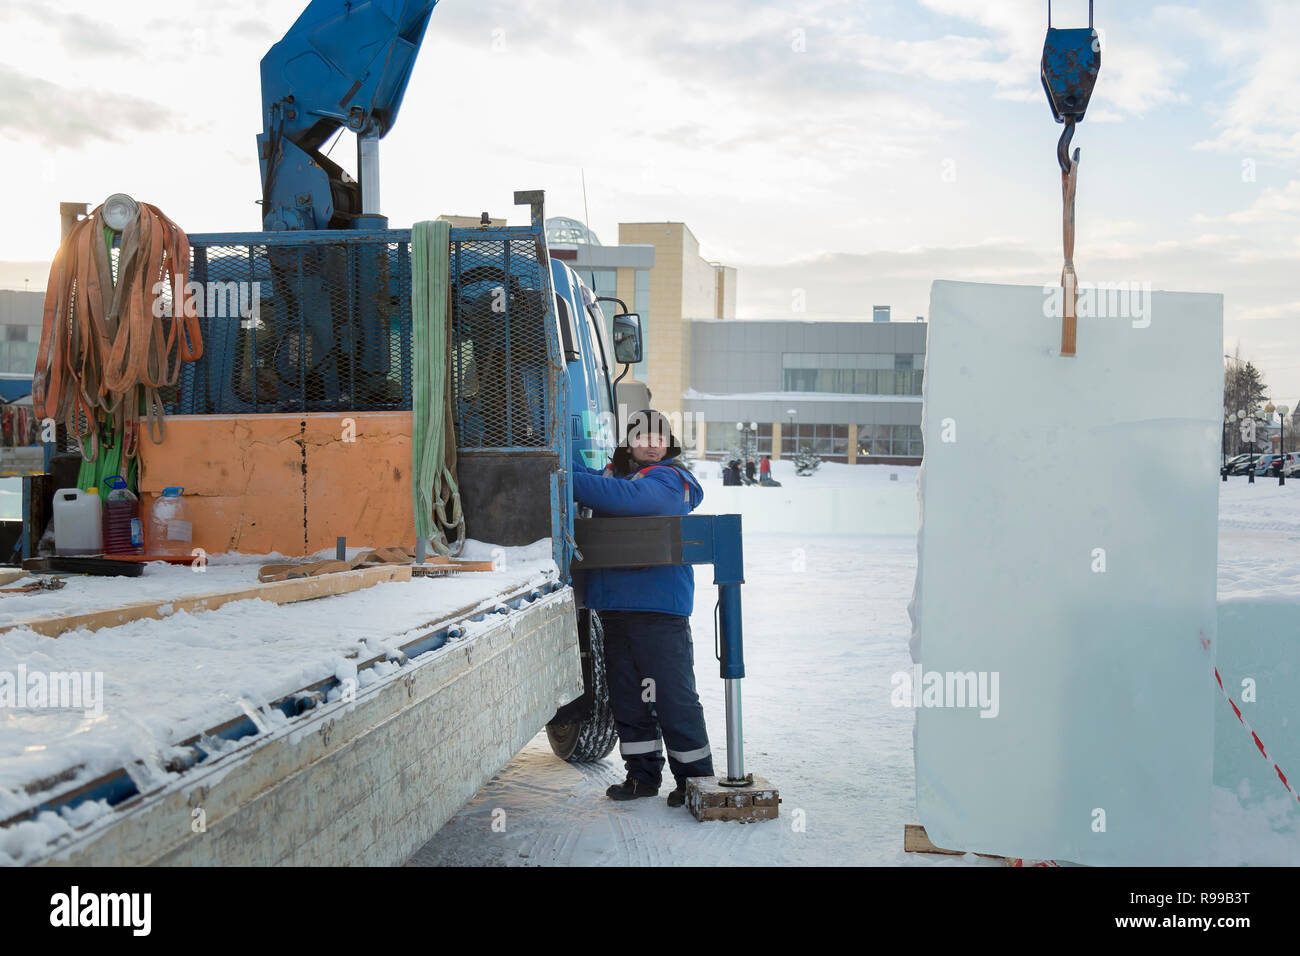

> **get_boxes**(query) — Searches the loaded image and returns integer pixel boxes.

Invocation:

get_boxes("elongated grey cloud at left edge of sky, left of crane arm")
[0,64,166,148]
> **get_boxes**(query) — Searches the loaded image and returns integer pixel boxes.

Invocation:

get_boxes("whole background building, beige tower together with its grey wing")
[546,217,927,464]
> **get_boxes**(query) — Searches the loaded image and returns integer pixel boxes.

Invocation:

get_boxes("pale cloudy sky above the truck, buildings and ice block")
[0,0,1300,407]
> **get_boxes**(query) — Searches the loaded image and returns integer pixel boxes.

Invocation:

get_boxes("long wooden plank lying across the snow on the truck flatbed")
[0,564,411,637]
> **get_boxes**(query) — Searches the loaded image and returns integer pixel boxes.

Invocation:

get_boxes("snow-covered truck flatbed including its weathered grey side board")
[0,540,582,864]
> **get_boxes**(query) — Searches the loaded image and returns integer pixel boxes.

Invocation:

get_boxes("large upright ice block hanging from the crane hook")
[896,282,1223,865]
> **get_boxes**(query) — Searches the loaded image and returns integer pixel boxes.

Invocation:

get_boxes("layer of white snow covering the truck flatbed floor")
[0,538,556,822]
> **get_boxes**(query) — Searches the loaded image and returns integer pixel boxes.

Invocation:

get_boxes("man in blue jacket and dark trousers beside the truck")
[573,408,714,806]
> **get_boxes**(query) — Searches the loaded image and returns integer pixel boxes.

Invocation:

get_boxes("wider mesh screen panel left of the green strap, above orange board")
[164,237,411,415]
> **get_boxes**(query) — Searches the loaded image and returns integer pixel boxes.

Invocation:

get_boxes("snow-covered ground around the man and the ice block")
[410,462,1300,866]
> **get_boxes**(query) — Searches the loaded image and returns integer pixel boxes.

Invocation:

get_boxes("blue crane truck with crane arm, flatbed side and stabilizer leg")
[0,0,753,864]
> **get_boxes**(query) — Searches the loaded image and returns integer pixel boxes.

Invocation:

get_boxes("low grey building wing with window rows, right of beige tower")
[684,319,927,464]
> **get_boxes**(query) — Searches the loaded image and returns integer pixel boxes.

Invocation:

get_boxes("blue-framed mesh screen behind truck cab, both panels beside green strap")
[164,229,549,449]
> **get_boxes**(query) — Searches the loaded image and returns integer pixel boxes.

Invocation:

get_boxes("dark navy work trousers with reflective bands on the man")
[597,611,714,787]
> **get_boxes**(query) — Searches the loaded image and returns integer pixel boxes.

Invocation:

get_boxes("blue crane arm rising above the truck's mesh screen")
[257,0,438,230]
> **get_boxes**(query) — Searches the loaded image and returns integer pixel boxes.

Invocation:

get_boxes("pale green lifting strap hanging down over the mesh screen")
[411,220,465,557]
